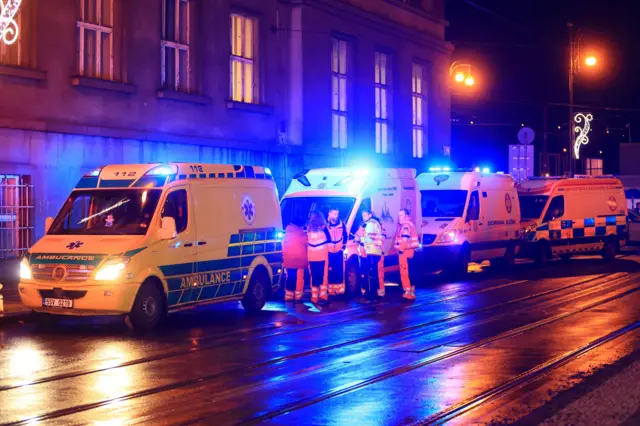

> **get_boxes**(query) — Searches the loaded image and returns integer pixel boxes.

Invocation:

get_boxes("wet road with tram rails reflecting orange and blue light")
[0,256,640,425]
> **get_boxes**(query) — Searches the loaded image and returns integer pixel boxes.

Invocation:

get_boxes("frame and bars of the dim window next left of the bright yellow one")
[160,0,193,93]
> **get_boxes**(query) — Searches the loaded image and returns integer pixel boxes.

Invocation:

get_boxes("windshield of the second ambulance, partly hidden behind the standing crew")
[280,197,356,227]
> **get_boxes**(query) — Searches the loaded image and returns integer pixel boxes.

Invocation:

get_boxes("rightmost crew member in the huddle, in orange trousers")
[394,209,420,300]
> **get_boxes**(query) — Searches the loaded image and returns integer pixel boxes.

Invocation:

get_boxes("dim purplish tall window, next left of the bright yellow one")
[160,0,191,92]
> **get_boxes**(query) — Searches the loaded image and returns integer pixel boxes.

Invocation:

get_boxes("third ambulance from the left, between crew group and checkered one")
[418,168,520,275]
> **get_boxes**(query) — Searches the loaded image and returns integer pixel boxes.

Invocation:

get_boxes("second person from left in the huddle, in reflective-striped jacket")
[307,212,331,304]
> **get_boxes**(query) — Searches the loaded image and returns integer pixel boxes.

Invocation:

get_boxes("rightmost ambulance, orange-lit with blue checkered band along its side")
[518,176,628,262]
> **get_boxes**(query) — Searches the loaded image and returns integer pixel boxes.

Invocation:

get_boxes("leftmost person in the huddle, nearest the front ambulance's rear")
[282,218,309,302]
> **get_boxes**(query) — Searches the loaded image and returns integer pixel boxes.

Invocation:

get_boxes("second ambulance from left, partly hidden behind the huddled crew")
[280,168,421,294]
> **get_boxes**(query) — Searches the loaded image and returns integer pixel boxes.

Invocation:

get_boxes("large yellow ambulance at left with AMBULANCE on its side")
[19,163,282,329]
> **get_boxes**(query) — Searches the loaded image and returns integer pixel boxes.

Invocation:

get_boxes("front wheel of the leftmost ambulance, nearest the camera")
[129,281,166,331]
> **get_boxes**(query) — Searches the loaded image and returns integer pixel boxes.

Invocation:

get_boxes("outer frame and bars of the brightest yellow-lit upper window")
[229,11,261,104]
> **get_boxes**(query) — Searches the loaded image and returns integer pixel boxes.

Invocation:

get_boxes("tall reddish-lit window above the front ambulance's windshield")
[78,0,114,80]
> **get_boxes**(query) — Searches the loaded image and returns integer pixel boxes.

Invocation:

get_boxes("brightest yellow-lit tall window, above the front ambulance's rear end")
[231,14,258,103]
